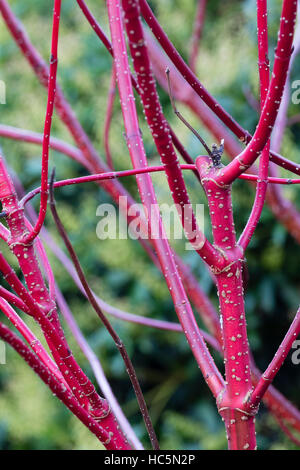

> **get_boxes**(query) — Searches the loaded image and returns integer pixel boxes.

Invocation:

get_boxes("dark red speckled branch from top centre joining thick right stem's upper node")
[122,0,220,265]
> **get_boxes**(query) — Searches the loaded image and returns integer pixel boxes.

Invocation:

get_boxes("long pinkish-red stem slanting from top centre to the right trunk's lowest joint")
[107,1,224,397]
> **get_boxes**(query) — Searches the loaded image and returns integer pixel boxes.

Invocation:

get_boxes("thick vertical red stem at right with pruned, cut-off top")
[196,157,256,450]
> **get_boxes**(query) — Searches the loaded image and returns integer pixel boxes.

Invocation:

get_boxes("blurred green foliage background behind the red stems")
[0,0,300,449]
